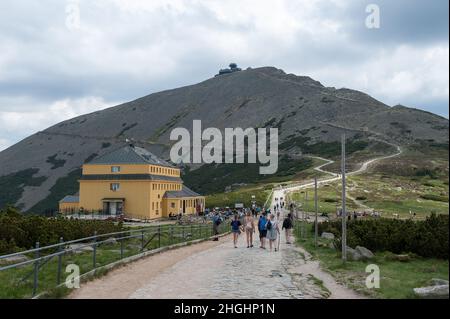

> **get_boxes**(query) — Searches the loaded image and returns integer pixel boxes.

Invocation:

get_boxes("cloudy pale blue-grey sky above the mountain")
[0,0,449,150]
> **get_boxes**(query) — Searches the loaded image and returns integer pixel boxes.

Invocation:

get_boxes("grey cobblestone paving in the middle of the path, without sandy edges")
[131,230,312,298]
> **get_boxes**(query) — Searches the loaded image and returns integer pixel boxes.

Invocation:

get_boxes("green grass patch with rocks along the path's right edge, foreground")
[296,223,449,299]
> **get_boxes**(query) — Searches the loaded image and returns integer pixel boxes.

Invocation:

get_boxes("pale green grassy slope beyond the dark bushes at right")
[291,174,449,218]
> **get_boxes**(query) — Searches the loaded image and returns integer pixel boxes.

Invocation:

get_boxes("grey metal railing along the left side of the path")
[0,223,226,298]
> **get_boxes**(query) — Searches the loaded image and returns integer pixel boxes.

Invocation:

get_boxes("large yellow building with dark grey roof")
[59,145,205,219]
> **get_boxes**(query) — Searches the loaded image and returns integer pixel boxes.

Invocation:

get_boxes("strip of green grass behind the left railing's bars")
[0,224,225,299]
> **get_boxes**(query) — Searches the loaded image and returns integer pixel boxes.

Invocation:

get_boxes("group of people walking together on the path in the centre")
[230,211,294,251]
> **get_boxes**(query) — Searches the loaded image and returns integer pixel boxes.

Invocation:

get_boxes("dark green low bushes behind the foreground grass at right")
[319,214,449,259]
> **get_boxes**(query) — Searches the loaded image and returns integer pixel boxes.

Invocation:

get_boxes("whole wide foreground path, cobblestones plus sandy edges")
[69,190,366,299]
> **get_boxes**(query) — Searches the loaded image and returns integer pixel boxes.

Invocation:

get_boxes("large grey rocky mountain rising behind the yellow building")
[0,67,449,211]
